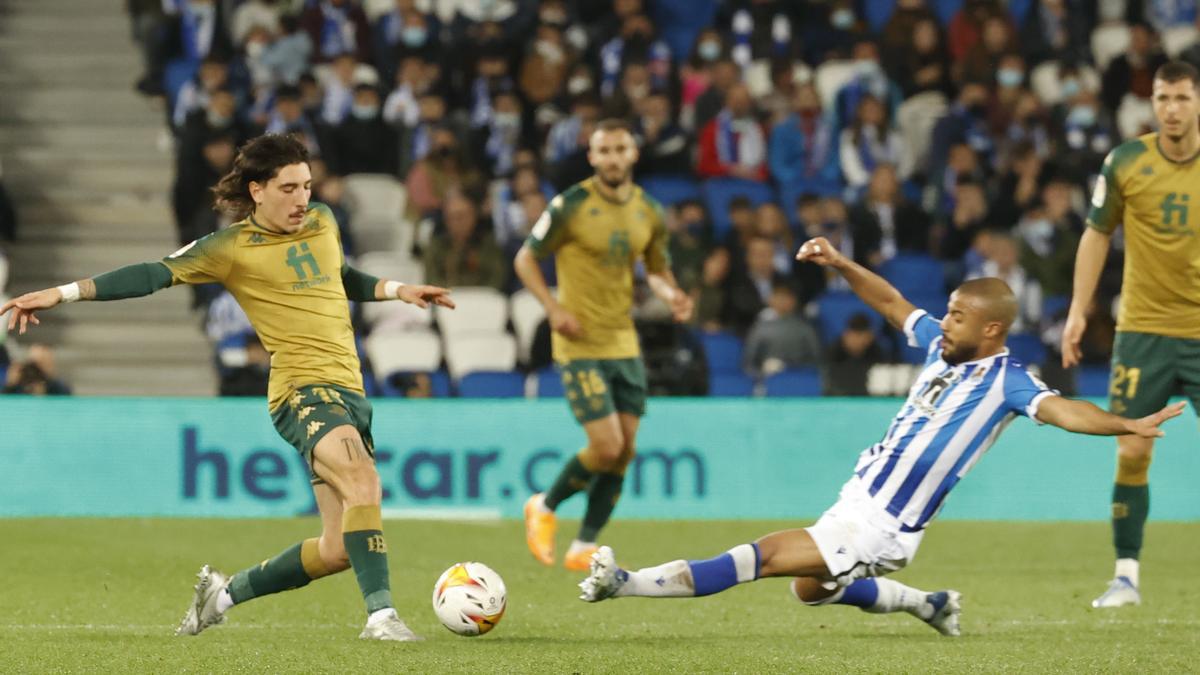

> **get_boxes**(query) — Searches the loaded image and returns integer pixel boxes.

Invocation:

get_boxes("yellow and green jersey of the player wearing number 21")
[1087,133,1200,339]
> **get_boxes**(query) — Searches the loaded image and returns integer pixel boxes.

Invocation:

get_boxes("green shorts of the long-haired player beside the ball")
[271,384,374,485]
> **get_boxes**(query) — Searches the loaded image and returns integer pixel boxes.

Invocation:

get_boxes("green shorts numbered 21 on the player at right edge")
[1109,331,1200,418]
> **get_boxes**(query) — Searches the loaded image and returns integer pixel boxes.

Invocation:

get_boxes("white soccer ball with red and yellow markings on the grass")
[433,562,508,637]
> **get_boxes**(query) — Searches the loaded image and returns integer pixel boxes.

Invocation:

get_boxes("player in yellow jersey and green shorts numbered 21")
[1062,61,1200,608]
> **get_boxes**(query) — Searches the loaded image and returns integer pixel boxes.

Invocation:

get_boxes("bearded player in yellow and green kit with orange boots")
[514,120,692,571]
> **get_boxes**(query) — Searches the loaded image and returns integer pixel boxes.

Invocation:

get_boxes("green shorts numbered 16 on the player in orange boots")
[558,358,646,424]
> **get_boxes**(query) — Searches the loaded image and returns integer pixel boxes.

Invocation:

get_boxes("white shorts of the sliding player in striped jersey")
[805,477,925,586]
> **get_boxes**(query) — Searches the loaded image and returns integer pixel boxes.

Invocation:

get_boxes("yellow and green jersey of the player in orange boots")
[526,178,671,362]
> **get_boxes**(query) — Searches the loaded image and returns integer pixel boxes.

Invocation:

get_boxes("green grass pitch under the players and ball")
[0,519,1200,673]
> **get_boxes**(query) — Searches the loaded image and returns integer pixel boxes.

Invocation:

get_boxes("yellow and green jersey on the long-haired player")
[162,203,364,410]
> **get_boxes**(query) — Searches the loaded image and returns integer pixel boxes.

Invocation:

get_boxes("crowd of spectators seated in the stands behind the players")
[119,0,1200,393]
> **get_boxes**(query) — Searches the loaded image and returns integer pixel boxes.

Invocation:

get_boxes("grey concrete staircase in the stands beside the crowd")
[0,0,216,396]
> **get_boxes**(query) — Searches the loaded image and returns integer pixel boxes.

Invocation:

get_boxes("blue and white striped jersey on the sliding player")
[854,310,1057,532]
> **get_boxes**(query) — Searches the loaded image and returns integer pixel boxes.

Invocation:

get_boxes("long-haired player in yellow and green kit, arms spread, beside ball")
[0,136,454,641]
